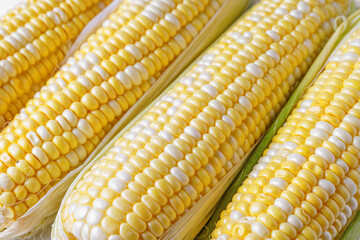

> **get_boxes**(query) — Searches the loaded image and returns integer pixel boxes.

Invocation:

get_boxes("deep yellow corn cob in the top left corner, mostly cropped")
[0,0,111,127]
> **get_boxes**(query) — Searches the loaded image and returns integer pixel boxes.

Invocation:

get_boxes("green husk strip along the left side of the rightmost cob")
[197,10,360,240]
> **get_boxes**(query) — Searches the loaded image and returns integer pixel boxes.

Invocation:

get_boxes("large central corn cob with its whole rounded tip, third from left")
[59,0,348,239]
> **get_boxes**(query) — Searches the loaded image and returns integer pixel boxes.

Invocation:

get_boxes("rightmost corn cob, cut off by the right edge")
[213,8,360,240]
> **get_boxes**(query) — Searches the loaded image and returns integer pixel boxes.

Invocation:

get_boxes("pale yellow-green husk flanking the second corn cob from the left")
[0,0,250,239]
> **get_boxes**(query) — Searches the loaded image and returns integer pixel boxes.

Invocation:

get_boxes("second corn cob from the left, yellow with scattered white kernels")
[0,0,246,231]
